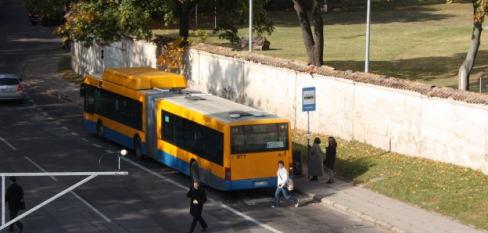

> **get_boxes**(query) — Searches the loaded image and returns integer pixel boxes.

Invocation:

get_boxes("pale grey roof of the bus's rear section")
[157,89,285,123]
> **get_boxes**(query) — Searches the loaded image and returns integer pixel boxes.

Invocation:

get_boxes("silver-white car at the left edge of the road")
[0,74,24,104]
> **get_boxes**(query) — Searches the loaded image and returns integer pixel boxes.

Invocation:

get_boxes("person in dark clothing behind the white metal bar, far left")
[5,176,24,233]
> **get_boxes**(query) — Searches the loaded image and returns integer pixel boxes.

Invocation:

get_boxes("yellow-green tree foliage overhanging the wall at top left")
[54,0,171,46]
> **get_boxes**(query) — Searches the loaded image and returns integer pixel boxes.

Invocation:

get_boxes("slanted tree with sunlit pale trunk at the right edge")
[458,0,487,90]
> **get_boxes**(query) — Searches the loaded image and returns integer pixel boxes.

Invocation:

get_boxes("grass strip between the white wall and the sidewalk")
[293,130,488,230]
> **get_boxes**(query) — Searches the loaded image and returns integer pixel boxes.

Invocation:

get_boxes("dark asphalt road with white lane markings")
[0,0,384,233]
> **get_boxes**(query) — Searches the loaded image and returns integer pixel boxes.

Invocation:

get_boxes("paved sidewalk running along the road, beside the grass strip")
[21,51,487,233]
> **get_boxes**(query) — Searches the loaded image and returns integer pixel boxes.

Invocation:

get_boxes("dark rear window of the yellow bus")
[230,123,289,154]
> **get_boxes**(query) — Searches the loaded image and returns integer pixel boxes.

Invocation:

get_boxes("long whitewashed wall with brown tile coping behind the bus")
[72,39,488,174]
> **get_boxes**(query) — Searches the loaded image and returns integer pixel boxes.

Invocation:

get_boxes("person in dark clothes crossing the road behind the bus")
[186,180,208,232]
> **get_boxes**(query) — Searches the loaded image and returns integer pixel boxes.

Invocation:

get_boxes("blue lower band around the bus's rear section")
[157,150,277,190]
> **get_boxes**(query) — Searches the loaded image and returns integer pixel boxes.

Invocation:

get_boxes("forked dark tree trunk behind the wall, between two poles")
[292,0,324,66]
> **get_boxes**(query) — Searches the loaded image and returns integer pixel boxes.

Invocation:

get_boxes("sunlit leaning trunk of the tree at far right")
[458,4,483,91]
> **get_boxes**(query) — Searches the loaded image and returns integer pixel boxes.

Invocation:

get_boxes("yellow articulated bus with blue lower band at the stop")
[80,67,293,190]
